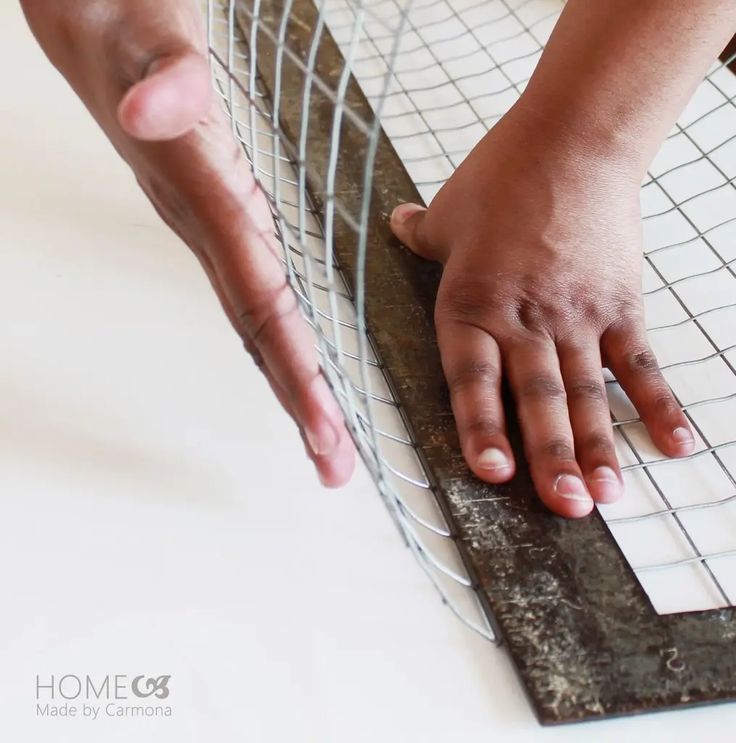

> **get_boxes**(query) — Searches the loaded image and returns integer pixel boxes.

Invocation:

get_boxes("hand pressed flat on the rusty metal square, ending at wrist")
[391,107,694,517]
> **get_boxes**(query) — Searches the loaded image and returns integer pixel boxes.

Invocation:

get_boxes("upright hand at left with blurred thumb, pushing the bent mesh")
[22,0,354,486]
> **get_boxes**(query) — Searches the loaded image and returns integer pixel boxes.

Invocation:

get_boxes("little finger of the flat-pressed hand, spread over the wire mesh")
[601,323,695,457]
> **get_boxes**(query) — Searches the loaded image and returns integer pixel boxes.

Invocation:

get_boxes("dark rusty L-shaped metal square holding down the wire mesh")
[239,0,736,723]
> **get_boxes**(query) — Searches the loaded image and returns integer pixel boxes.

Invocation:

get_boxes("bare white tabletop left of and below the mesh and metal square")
[0,2,736,743]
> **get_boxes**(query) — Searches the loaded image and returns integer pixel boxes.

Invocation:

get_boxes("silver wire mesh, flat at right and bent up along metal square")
[206,0,736,620]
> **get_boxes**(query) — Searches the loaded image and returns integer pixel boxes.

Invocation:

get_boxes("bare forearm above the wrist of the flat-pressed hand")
[517,0,736,174]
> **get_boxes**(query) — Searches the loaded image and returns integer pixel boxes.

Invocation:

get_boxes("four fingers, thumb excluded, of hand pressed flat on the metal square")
[437,314,694,518]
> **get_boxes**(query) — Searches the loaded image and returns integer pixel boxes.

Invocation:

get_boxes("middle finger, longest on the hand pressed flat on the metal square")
[502,338,593,518]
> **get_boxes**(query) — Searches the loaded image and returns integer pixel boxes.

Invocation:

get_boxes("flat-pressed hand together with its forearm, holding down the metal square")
[392,0,736,517]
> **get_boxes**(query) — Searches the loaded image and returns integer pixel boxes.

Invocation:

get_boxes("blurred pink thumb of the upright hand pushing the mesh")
[118,47,212,141]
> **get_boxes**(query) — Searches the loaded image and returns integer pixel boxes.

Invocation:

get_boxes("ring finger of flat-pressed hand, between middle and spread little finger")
[557,335,623,503]
